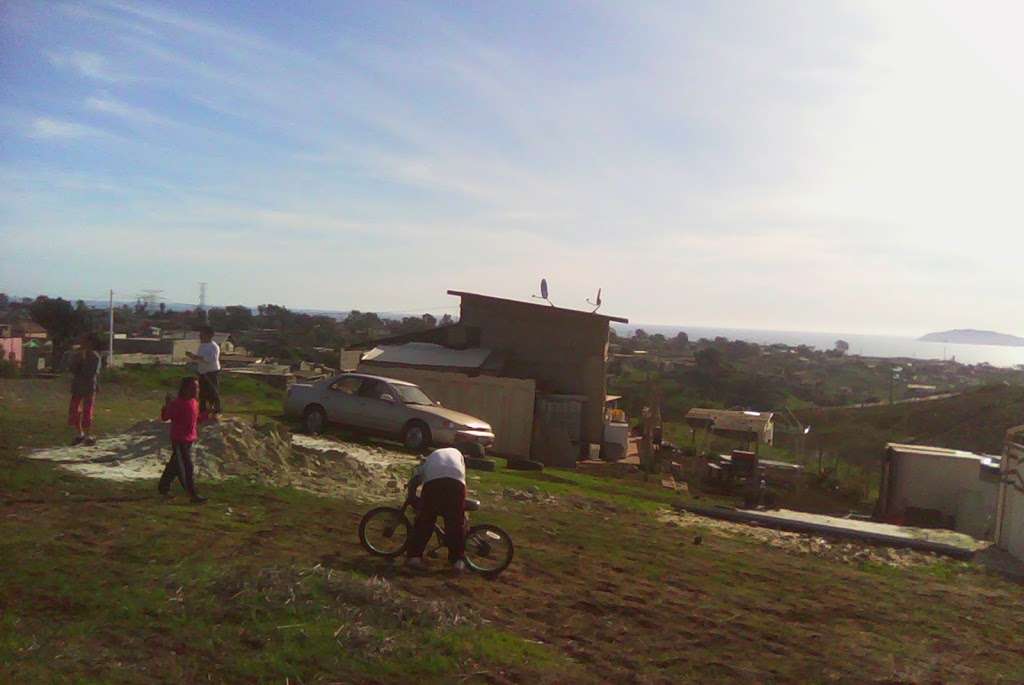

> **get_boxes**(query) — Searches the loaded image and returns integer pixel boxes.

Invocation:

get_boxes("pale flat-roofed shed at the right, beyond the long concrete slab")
[874,442,1001,540]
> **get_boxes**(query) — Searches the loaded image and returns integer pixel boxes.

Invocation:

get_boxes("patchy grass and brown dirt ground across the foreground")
[6,372,1024,684]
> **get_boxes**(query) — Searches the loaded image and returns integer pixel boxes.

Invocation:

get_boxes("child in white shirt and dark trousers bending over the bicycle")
[406,443,483,572]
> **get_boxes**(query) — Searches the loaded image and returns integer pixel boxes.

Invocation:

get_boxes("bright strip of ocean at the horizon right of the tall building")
[613,324,1024,367]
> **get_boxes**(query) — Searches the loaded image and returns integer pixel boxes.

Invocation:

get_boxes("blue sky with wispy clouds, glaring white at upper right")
[0,0,1024,335]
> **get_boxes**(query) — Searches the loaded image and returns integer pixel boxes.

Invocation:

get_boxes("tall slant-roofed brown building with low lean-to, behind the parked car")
[342,291,628,458]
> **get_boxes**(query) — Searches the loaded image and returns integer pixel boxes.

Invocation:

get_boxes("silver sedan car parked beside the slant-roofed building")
[285,374,495,451]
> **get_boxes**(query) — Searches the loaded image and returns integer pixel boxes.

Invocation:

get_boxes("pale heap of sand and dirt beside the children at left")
[28,418,418,501]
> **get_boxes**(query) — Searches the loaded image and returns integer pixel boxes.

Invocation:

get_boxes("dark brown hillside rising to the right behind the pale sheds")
[797,385,1024,466]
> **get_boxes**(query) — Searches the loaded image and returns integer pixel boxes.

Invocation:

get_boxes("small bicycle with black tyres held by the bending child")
[359,493,515,577]
